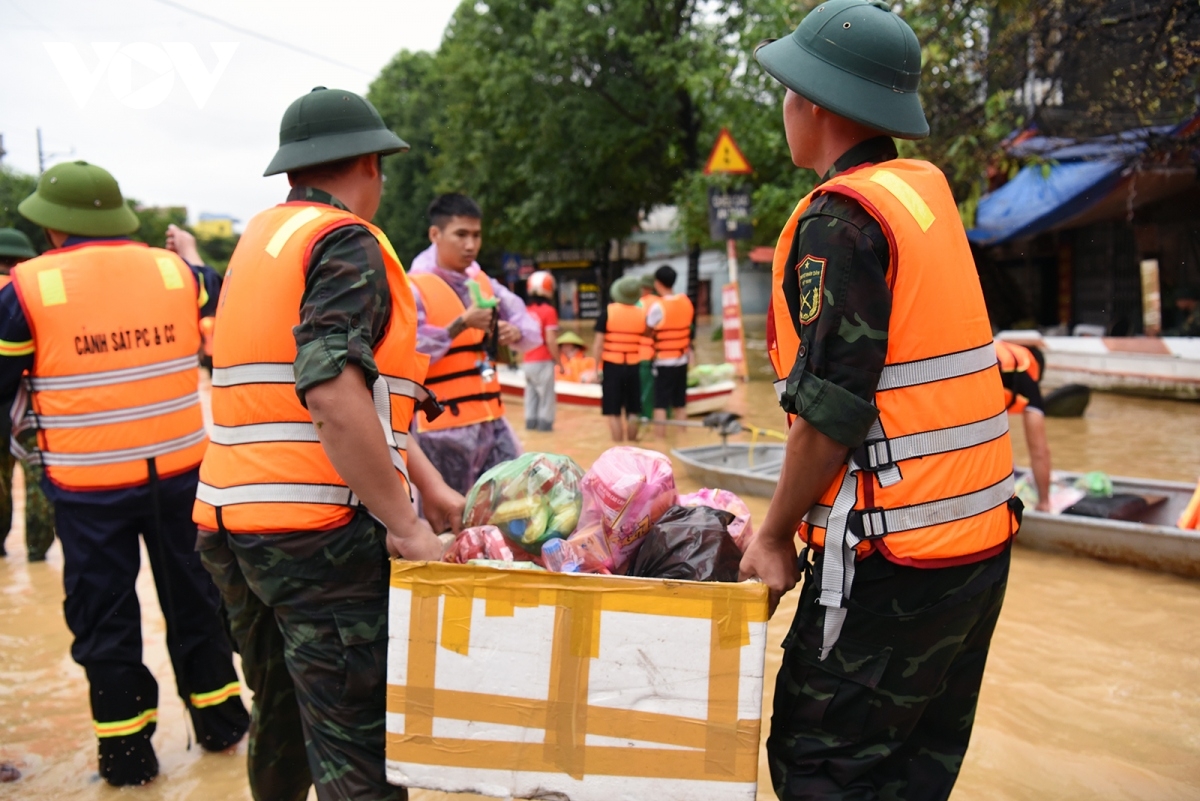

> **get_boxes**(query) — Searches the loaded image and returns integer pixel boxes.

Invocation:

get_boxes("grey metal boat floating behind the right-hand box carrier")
[671,442,1200,578]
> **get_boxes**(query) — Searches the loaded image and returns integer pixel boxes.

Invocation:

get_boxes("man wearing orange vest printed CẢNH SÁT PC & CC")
[0,162,250,785]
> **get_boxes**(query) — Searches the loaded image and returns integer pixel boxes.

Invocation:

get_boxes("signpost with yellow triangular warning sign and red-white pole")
[704,128,754,380]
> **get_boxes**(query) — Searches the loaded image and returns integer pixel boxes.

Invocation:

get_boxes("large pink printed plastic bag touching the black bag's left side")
[576,446,677,573]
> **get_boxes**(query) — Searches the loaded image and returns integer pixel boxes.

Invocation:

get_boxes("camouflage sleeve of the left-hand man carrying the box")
[293,225,391,403]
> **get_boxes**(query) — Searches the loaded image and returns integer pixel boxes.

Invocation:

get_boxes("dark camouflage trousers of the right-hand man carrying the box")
[767,547,1012,801]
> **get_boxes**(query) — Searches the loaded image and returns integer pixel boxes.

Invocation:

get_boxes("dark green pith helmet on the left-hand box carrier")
[263,86,408,175]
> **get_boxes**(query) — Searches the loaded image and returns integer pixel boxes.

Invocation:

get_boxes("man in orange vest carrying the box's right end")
[742,0,1020,800]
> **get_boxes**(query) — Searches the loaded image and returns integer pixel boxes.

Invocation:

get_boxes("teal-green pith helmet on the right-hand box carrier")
[755,0,929,139]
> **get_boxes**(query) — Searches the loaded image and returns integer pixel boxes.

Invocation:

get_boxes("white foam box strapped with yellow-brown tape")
[388,561,767,801]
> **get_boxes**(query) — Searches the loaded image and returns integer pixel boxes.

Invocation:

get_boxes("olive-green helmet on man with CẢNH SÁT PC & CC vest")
[17,162,138,236]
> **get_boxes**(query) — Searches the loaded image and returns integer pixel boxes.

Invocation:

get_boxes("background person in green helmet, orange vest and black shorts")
[592,276,646,442]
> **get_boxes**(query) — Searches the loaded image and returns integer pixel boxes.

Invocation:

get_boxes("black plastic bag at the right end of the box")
[629,506,742,582]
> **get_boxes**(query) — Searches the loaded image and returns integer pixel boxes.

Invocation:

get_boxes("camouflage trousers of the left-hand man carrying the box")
[197,514,407,801]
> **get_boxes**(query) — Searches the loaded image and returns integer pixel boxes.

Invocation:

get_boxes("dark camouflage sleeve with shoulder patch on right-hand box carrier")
[780,194,892,448]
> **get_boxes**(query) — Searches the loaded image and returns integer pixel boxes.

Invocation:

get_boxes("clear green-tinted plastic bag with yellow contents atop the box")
[463,453,583,556]
